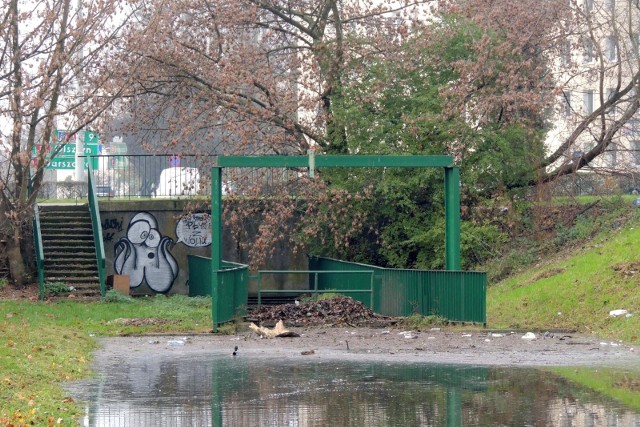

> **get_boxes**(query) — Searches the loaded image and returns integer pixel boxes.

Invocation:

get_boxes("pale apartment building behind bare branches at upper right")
[546,0,640,179]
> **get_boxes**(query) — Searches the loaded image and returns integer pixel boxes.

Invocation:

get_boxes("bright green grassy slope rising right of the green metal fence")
[487,209,640,343]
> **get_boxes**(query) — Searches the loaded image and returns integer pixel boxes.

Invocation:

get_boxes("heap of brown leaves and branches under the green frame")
[247,296,395,327]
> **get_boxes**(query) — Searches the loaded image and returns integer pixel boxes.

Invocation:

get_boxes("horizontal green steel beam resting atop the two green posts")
[218,155,454,168]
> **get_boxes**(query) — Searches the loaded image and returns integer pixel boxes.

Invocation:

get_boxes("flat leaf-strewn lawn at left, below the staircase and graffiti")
[0,296,211,426]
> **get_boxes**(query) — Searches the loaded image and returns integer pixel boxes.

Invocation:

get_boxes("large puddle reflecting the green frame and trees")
[71,355,640,427]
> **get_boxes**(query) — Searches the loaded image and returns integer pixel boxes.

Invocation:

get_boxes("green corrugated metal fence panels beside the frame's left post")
[187,255,249,328]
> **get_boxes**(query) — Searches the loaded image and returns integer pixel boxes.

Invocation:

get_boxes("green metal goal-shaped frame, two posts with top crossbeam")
[211,151,460,330]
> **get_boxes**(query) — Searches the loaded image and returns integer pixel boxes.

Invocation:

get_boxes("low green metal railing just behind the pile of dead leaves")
[255,270,374,307]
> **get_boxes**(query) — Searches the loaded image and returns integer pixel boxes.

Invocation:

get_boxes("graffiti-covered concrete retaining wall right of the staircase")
[100,200,307,295]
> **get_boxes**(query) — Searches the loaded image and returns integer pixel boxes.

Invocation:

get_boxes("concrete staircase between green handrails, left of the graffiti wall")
[40,205,100,298]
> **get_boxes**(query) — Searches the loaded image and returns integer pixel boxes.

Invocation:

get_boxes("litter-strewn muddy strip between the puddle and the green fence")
[92,327,640,368]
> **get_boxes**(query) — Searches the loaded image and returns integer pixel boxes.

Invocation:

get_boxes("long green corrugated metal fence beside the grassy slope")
[309,256,487,324]
